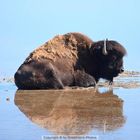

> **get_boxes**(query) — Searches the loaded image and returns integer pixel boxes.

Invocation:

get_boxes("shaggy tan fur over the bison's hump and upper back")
[25,33,92,62]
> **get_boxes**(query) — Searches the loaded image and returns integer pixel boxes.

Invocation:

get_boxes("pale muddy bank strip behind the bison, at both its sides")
[0,71,140,88]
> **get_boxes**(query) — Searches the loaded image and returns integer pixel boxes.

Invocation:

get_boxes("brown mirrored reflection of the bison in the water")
[15,89,125,135]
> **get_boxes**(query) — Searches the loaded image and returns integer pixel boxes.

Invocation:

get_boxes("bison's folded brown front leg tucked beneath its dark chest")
[74,70,96,87]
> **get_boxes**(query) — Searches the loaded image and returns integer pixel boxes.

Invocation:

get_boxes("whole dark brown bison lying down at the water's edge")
[14,33,126,89]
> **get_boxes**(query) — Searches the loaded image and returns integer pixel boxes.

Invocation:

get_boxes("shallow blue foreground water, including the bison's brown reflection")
[0,83,140,140]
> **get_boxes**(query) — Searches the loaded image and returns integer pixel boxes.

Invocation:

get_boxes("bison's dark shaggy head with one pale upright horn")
[91,40,126,82]
